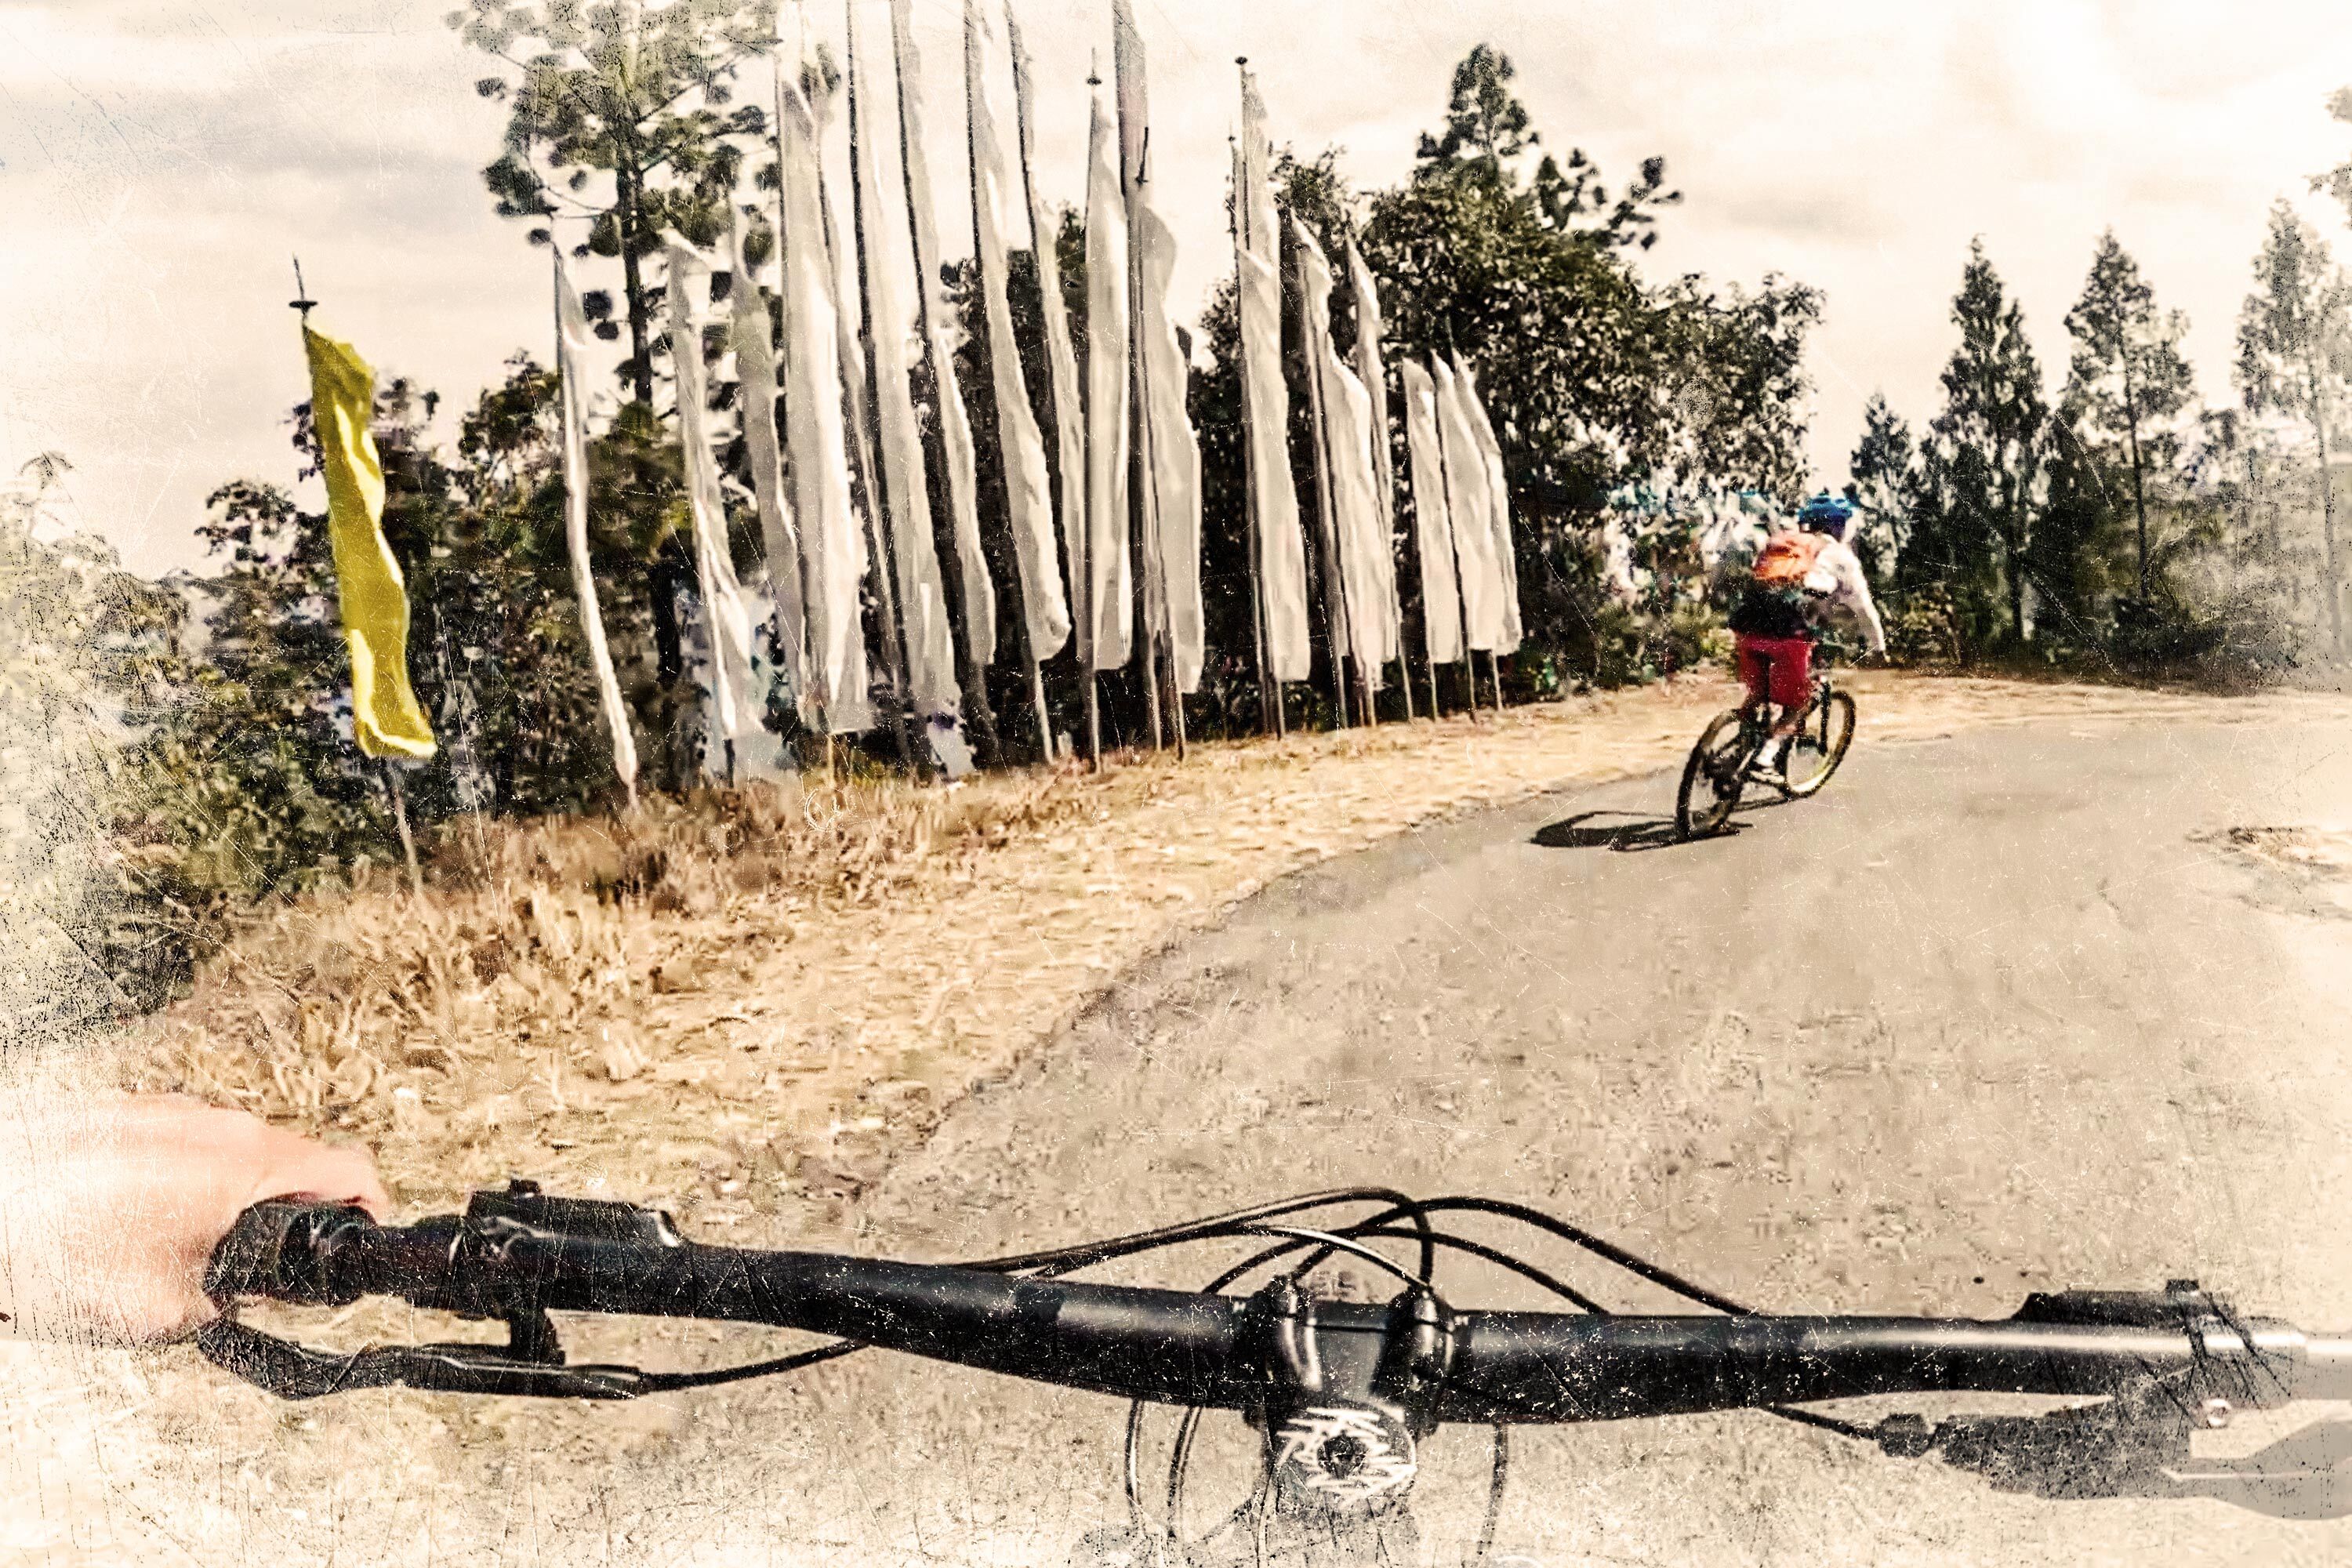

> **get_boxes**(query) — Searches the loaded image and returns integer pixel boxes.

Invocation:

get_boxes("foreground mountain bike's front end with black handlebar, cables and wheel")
[200,1182,2352,1568]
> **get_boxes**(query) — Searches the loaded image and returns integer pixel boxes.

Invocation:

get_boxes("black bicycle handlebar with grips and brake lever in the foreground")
[202,1182,2352,1429]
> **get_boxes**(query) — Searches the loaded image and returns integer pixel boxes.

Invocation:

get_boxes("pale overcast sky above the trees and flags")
[0,0,2352,572]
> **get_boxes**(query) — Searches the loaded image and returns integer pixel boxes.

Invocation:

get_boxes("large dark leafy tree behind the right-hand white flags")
[1195,49,1820,713]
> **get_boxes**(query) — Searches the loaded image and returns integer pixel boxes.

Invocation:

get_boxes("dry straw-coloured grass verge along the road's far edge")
[119,675,2352,1234]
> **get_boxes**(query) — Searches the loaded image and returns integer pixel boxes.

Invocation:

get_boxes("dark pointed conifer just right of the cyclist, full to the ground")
[1905,240,2049,642]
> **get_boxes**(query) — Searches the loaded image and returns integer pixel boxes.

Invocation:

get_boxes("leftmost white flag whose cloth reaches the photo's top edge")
[844,0,964,760]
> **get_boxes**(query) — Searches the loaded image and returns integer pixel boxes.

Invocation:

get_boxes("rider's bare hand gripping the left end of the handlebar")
[0,1095,393,1345]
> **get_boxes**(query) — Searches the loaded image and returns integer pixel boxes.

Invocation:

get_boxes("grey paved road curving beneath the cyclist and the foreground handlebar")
[36,724,2352,1568]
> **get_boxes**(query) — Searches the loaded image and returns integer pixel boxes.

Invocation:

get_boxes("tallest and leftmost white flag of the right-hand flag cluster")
[1235,71,1315,682]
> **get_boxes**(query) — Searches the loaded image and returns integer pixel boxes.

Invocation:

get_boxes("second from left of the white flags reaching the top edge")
[889,0,997,755]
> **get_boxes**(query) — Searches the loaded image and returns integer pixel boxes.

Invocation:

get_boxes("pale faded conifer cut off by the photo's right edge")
[2237,200,2352,654]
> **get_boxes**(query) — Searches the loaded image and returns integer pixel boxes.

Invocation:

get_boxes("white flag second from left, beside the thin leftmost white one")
[663,233,762,757]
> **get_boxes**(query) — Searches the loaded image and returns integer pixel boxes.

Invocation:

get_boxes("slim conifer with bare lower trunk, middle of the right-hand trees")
[2065,228,2197,600]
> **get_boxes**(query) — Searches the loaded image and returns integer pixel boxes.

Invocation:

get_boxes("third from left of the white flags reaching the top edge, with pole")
[964,0,1070,762]
